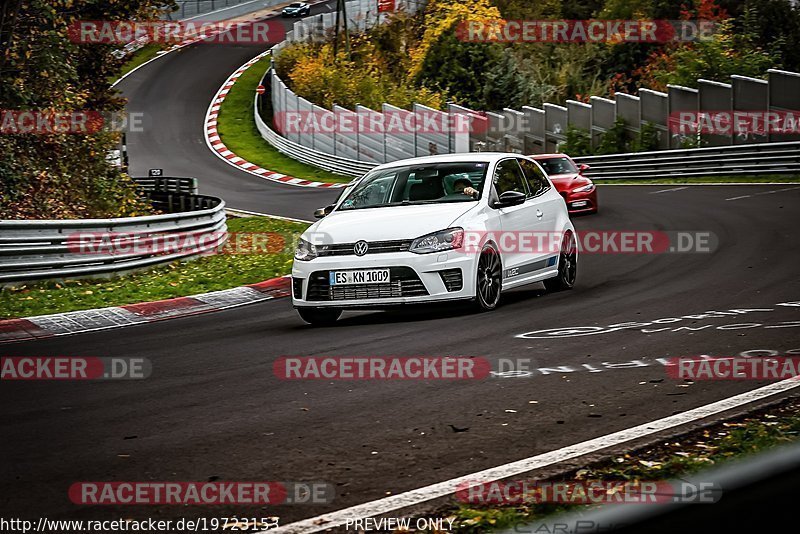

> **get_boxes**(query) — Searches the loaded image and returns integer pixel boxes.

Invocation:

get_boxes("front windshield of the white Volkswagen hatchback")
[338,161,489,210]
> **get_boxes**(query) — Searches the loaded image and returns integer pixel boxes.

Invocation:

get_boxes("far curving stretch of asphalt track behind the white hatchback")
[118,4,338,219]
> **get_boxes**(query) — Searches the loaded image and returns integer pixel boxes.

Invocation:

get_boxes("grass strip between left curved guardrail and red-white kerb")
[0,217,307,318]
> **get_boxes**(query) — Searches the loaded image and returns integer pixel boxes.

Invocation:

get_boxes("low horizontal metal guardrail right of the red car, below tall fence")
[574,142,800,180]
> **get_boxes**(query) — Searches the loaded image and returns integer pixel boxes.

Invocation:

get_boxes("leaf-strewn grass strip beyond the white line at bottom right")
[422,398,800,533]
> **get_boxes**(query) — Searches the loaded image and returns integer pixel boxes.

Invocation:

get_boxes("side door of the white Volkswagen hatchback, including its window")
[492,158,536,287]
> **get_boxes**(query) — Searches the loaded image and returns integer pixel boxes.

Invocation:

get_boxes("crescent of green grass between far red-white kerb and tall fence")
[217,57,353,182]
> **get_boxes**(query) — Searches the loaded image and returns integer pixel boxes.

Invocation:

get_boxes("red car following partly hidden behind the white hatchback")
[531,154,597,215]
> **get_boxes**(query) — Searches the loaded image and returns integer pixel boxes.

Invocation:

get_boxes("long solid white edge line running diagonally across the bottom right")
[264,378,800,534]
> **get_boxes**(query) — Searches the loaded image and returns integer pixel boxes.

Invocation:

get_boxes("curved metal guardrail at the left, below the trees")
[0,183,228,285]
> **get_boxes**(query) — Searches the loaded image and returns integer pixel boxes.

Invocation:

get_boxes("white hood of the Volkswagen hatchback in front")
[304,202,478,244]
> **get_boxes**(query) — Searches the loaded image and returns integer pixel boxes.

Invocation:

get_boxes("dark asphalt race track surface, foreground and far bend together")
[0,7,800,523]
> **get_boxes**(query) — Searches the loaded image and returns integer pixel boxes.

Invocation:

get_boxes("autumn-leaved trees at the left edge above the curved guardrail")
[0,0,174,218]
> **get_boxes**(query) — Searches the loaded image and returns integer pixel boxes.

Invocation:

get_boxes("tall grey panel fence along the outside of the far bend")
[257,0,800,168]
